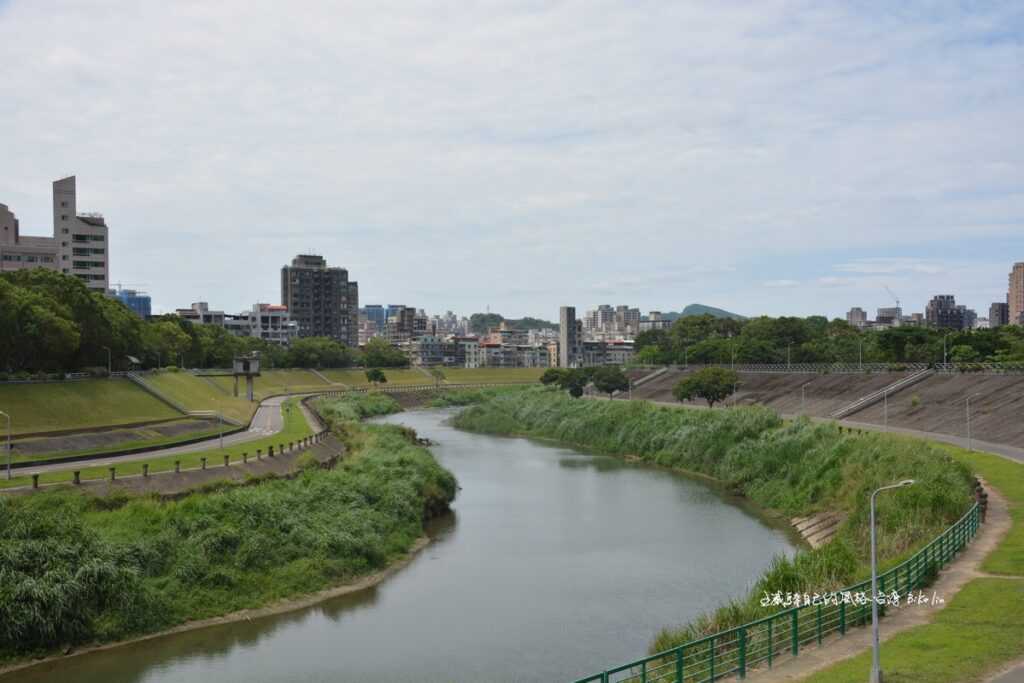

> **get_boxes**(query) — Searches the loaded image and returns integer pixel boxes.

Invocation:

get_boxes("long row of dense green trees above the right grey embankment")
[636,315,1024,365]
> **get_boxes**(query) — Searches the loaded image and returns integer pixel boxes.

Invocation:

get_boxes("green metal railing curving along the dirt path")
[575,504,981,683]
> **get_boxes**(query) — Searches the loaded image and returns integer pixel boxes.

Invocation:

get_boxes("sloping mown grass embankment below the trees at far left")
[0,379,180,434]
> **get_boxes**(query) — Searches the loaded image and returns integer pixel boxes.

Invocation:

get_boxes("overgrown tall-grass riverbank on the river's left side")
[0,393,456,661]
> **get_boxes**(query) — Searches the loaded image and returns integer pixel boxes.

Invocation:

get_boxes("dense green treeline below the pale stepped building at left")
[0,268,409,376]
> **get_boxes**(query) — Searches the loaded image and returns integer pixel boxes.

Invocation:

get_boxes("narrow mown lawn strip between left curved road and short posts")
[0,398,312,488]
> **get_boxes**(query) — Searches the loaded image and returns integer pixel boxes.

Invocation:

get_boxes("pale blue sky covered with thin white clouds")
[0,0,1024,319]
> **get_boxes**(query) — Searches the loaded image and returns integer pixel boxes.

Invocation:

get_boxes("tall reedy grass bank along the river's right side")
[454,388,972,651]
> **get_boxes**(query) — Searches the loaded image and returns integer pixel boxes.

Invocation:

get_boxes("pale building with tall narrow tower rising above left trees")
[0,175,111,292]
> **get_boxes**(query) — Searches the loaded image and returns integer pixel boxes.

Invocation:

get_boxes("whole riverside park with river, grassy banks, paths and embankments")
[0,365,1024,683]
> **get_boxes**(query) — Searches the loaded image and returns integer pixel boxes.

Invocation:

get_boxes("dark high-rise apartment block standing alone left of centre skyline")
[281,254,359,347]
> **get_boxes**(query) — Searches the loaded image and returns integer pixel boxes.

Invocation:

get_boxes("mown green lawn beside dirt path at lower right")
[804,444,1024,683]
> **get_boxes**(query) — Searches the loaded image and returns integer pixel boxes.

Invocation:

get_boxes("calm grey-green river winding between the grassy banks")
[8,411,793,683]
